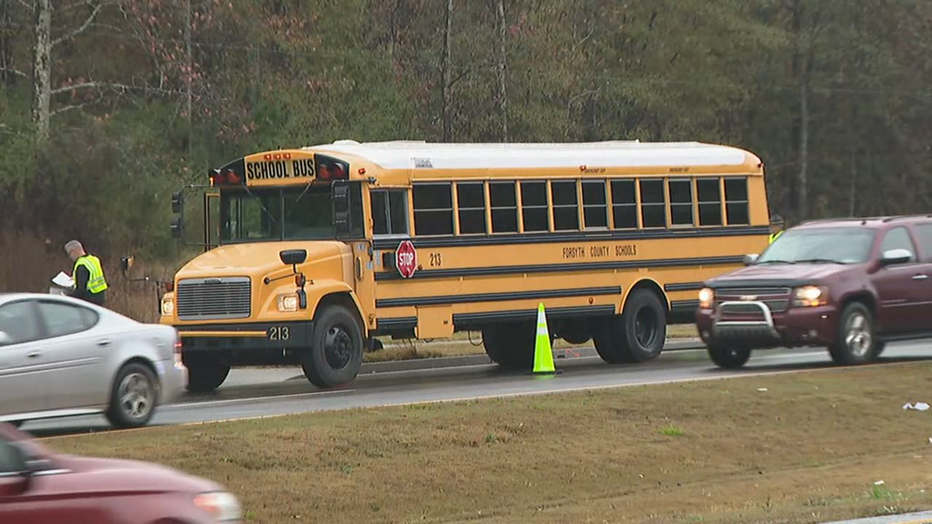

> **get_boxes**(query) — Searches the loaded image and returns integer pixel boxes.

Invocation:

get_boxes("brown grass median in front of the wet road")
[48,363,932,523]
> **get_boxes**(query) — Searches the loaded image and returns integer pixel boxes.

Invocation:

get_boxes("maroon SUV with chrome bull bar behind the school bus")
[696,215,932,368]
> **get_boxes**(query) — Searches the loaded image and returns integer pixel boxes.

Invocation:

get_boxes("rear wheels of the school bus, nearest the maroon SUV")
[594,289,667,364]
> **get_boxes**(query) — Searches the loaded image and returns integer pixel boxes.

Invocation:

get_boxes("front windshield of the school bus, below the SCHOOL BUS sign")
[220,186,334,243]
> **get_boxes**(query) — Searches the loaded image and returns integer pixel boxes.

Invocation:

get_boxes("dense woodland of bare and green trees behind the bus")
[0,0,932,258]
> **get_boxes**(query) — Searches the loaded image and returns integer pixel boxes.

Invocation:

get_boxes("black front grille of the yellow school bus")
[176,277,251,320]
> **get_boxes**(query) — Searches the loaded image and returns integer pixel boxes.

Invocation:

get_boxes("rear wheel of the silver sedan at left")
[105,362,159,428]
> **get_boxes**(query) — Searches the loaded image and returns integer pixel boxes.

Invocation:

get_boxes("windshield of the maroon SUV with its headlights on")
[757,228,874,264]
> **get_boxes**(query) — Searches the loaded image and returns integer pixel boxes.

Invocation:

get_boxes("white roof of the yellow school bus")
[304,140,757,169]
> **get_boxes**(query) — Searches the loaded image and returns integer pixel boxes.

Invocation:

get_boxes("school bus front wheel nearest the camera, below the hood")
[301,305,364,388]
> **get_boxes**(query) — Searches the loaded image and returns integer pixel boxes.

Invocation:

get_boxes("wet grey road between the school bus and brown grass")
[23,341,932,437]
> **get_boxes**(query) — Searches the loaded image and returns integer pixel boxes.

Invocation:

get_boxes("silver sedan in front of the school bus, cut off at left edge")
[0,293,187,427]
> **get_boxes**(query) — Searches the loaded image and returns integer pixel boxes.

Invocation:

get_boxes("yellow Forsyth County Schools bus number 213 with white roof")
[161,140,769,391]
